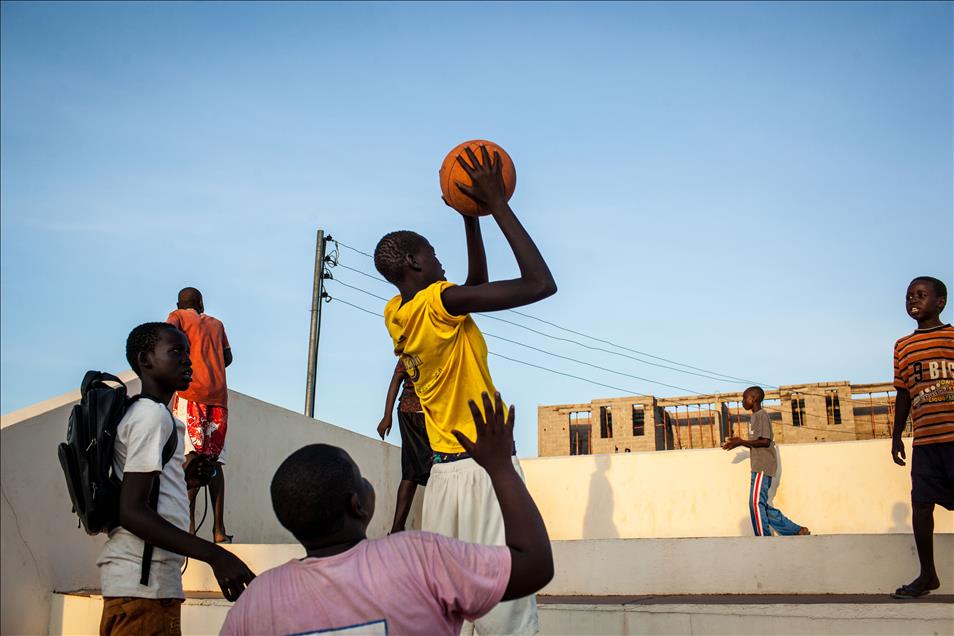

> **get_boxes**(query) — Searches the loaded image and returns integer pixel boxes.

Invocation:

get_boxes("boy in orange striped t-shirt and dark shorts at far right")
[891,276,954,599]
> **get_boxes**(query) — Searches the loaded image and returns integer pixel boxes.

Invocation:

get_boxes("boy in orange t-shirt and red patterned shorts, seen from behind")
[166,287,232,543]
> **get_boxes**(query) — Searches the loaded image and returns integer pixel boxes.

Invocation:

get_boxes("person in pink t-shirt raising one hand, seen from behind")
[221,393,553,636]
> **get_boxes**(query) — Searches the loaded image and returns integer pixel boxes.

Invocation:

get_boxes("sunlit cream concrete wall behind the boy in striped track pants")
[521,440,954,540]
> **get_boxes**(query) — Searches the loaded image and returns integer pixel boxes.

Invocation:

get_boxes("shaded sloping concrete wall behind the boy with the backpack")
[0,374,420,634]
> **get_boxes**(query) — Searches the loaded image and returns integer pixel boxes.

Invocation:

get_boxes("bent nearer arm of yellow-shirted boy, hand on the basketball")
[441,146,557,316]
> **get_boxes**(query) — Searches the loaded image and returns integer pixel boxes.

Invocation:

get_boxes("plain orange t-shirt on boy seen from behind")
[166,309,229,407]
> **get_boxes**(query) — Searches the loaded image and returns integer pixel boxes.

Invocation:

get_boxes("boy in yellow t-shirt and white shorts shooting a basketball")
[374,146,556,634]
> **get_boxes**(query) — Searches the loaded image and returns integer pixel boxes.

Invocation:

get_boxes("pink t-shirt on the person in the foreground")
[221,532,510,636]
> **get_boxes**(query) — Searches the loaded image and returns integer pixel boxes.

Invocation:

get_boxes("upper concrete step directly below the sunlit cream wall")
[175,534,954,597]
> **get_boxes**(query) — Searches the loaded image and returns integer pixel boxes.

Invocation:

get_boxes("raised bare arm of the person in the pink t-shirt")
[454,393,553,601]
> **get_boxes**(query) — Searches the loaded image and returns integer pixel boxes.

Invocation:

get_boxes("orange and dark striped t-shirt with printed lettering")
[894,325,954,446]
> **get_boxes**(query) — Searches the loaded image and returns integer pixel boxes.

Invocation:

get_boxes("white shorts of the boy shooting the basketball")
[421,457,540,636]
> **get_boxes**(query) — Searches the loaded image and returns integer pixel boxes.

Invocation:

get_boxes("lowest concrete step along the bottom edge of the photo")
[49,592,954,636]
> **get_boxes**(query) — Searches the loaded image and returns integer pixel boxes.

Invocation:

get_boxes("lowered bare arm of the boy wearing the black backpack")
[119,472,255,601]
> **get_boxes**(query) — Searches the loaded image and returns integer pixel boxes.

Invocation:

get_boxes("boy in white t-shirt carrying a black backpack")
[97,322,255,635]
